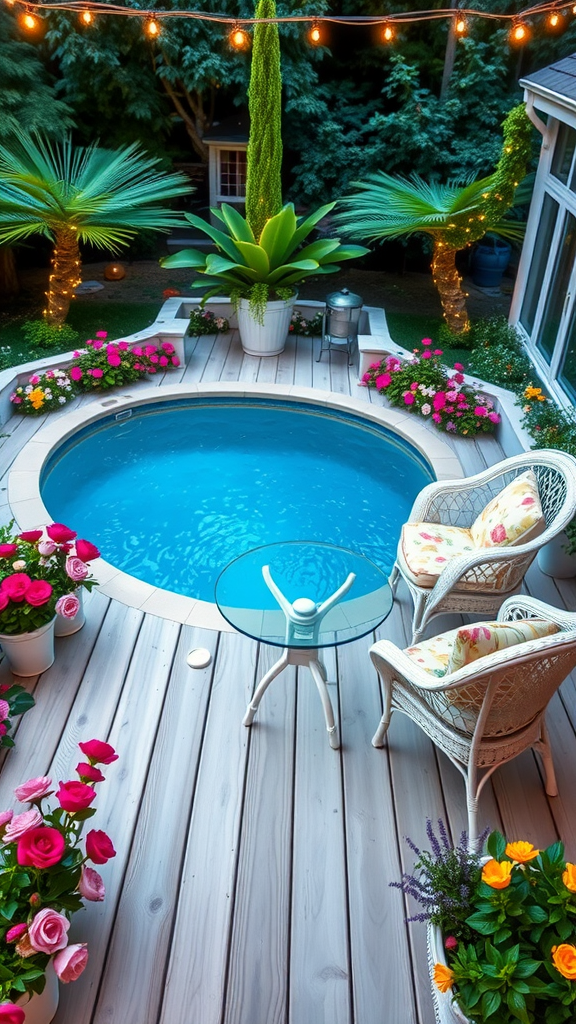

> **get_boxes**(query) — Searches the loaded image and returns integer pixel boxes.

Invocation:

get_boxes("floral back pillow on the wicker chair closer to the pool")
[470,469,546,548]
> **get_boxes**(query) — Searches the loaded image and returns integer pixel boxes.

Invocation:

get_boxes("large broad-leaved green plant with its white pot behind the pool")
[161,203,368,355]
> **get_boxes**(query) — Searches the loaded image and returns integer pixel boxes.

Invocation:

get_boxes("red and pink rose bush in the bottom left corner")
[0,739,118,1011]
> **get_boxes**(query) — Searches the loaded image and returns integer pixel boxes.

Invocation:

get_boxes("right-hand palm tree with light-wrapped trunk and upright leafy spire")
[334,104,532,334]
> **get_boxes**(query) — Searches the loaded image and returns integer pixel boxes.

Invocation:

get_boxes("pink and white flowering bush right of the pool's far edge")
[362,338,500,437]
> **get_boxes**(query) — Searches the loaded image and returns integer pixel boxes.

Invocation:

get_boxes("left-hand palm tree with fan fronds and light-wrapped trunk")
[0,131,192,327]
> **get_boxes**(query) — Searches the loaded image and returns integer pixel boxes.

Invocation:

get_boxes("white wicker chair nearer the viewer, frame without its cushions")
[370,596,576,842]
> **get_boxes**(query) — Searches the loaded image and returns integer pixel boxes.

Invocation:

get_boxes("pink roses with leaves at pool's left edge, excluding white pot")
[0,521,99,634]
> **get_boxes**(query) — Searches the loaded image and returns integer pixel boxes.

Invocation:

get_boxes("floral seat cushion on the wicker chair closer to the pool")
[400,522,475,587]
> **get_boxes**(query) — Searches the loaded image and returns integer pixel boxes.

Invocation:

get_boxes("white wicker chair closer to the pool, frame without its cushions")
[389,449,576,643]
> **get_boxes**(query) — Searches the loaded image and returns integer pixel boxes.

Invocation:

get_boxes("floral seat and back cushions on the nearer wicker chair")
[404,618,559,679]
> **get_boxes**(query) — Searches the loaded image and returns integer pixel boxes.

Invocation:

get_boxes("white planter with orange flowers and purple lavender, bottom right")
[398,821,576,1024]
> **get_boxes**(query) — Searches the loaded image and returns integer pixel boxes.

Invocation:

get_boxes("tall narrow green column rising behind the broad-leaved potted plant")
[246,0,282,240]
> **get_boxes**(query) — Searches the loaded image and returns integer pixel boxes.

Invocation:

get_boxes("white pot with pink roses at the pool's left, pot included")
[0,521,99,676]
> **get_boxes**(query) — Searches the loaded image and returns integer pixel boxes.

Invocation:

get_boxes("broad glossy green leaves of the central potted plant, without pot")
[160,203,367,323]
